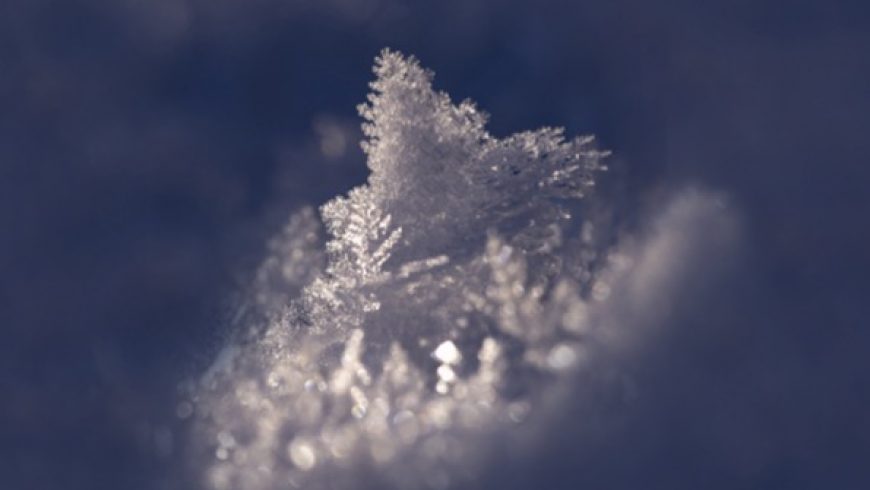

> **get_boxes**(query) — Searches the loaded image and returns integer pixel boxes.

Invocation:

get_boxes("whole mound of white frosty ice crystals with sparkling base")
[189,51,605,490]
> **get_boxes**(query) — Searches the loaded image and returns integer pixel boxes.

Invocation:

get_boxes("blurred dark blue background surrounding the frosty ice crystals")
[0,0,870,490]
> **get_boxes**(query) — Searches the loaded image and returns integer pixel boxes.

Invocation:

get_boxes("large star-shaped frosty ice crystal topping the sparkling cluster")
[354,51,603,259]
